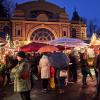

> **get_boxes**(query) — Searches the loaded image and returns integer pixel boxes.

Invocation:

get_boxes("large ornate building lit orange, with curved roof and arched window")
[0,0,87,46]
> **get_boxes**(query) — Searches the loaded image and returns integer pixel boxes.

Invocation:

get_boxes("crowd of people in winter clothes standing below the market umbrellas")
[0,47,100,100]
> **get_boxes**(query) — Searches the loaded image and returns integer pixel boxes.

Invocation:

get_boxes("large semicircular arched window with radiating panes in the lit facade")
[30,28,54,42]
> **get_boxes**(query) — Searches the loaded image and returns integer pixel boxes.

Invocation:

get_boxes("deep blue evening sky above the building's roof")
[14,0,100,27]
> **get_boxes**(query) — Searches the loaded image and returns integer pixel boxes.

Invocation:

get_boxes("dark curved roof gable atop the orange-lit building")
[14,0,68,20]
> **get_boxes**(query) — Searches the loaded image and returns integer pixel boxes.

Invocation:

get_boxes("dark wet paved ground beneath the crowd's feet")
[0,69,98,100]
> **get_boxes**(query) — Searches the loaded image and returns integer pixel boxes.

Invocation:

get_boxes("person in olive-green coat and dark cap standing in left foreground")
[11,51,31,100]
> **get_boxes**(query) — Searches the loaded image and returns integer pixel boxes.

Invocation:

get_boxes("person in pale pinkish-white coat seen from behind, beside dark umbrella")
[39,54,51,92]
